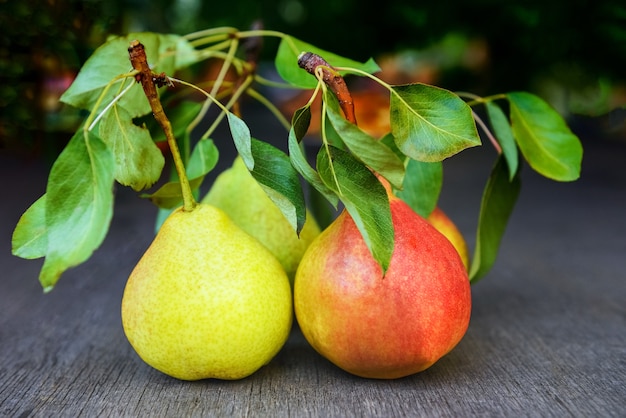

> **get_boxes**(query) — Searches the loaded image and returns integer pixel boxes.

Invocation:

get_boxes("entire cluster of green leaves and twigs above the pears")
[13,28,582,290]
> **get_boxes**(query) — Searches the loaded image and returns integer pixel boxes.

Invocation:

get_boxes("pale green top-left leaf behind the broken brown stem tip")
[61,32,197,118]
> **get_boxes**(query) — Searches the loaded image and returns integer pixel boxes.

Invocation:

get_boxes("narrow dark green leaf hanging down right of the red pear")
[469,155,521,283]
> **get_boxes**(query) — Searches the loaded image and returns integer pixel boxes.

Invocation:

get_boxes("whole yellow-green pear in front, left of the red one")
[122,204,293,380]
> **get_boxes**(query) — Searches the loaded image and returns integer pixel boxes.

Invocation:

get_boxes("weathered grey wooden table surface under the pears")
[0,129,626,417]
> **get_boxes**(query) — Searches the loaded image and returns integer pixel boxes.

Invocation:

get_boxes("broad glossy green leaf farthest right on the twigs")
[507,92,583,181]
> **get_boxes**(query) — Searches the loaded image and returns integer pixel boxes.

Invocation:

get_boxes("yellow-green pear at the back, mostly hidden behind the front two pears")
[202,157,320,283]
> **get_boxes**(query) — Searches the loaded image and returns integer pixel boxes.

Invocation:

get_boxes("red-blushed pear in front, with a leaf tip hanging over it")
[294,196,471,379]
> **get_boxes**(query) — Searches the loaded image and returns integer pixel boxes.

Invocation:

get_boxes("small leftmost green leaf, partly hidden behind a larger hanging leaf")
[12,193,48,259]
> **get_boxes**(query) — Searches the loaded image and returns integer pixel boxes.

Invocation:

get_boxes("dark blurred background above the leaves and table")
[0,0,626,155]
